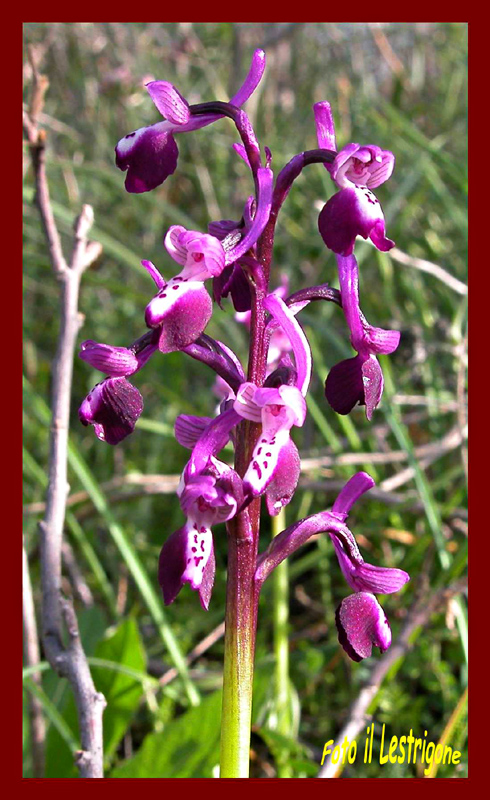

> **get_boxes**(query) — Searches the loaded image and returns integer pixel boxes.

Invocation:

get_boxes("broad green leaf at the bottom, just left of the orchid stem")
[110,692,221,778]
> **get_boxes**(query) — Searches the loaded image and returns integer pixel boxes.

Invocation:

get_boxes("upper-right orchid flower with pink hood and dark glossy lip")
[313,102,395,256]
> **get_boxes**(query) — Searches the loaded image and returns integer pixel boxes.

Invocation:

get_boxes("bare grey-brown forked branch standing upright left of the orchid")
[24,59,106,778]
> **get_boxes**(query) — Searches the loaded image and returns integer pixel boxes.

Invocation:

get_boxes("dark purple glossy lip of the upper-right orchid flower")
[318,186,395,256]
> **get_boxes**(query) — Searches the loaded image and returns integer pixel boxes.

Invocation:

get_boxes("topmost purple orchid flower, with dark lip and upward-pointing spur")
[115,50,265,193]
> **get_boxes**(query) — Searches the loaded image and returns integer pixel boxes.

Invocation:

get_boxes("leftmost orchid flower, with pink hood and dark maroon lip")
[78,334,157,444]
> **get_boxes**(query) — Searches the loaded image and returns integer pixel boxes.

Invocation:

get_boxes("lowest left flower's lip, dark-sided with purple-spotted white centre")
[158,521,214,609]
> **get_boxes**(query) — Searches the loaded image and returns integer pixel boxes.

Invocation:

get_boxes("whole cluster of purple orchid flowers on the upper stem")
[79,50,409,661]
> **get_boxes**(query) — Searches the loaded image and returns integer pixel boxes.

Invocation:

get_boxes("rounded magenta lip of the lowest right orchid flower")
[335,592,391,661]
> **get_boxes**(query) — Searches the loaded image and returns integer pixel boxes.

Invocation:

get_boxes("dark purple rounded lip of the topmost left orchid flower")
[116,122,179,194]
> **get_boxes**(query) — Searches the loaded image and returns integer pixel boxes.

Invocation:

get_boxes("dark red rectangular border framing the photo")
[17,12,472,798]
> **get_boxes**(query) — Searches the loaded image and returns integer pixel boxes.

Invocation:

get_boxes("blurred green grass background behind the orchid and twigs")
[24,23,467,777]
